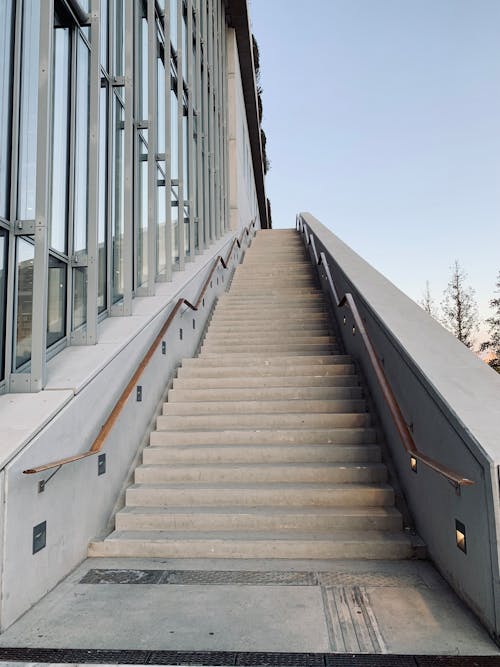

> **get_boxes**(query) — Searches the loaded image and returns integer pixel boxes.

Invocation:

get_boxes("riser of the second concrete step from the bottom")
[116,511,401,532]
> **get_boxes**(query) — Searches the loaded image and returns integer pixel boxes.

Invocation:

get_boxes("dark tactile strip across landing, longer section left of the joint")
[80,570,318,586]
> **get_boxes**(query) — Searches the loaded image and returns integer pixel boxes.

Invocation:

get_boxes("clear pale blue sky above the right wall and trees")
[249,0,500,330]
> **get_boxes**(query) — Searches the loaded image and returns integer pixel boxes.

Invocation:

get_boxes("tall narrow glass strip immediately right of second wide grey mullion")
[97,88,108,313]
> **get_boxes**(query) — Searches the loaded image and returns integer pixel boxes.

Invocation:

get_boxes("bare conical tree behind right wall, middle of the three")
[441,260,479,347]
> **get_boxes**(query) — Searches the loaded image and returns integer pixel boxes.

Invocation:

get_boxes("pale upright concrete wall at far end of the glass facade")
[227,28,260,230]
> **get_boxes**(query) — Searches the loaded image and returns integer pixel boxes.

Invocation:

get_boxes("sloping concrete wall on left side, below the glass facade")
[0,235,254,629]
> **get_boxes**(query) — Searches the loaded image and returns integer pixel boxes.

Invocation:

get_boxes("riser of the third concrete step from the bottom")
[126,486,394,507]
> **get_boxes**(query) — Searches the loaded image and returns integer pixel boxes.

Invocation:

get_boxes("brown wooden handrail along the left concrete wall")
[23,220,255,475]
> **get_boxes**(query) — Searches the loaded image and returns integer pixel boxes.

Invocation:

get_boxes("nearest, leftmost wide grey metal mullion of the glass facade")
[29,0,54,392]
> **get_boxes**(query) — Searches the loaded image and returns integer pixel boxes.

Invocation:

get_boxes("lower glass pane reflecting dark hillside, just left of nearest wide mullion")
[15,237,35,369]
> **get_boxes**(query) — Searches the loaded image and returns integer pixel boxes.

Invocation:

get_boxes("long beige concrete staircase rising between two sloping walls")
[89,230,412,559]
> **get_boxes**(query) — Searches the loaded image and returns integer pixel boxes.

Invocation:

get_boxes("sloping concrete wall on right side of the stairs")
[302,214,500,640]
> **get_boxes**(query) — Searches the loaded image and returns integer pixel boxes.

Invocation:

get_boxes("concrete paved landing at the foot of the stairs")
[0,559,500,655]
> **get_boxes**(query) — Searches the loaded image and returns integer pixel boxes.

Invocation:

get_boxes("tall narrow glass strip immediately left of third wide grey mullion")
[111,95,125,303]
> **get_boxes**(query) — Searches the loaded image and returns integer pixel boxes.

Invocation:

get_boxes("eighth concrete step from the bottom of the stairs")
[163,399,366,416]
